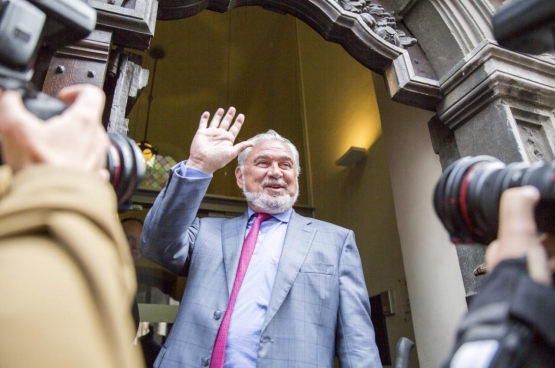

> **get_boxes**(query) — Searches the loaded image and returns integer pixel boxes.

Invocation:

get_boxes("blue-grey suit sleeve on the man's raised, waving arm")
[140,163,212,276]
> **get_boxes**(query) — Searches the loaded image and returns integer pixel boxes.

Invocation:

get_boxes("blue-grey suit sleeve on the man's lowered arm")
[336,231,382,368]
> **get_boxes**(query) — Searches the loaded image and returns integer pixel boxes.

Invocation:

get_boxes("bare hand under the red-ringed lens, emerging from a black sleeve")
[486,186,555,285]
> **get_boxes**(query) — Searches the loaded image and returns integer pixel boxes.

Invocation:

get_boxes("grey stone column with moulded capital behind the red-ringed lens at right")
[429,39,555,298]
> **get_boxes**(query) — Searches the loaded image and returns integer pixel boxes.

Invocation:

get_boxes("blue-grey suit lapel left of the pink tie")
[222,212,248,296]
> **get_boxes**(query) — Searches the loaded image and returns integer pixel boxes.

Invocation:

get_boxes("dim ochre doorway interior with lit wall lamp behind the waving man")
[129,7,418,366]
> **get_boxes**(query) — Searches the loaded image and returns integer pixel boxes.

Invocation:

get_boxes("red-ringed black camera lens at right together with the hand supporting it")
[434,156,555,285]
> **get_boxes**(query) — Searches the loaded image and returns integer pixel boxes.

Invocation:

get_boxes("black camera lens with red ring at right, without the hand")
[434,156,555,245]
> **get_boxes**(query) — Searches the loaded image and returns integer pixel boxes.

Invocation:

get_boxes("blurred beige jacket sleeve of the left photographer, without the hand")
[0,165,144,368]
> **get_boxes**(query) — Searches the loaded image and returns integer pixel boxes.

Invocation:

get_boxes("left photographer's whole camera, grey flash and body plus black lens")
[0,0,145,210]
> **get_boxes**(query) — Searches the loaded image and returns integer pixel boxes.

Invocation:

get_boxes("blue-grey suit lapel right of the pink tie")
[262,212,316,331]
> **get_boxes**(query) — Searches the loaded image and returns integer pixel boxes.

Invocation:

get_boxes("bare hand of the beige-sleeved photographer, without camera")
[0,85,109,179]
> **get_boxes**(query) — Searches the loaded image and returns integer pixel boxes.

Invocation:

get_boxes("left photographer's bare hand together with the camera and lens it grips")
[0,0,146,211]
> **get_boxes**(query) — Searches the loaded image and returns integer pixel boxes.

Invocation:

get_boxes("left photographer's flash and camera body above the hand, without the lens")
[0,0,96,120]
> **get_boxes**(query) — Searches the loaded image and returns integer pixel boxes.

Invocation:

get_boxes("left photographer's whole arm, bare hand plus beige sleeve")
[0,86,143,368]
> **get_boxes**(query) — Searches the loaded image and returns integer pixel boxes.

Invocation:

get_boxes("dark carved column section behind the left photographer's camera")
[36,0,158,134]
